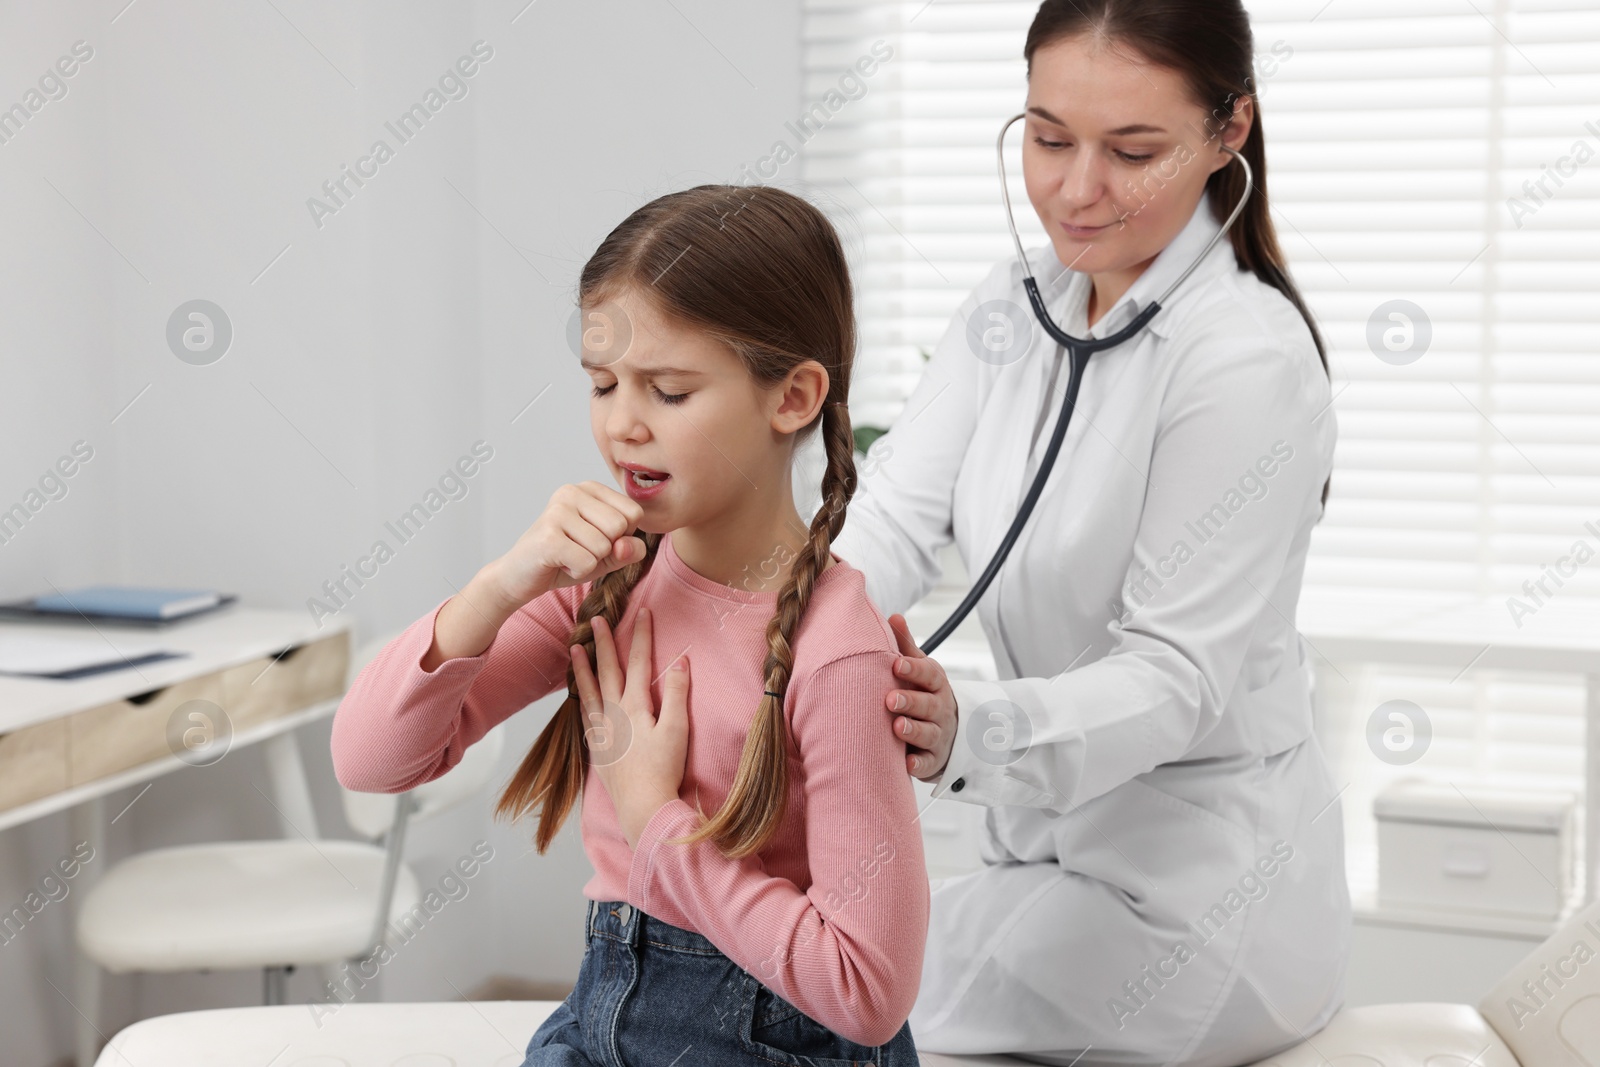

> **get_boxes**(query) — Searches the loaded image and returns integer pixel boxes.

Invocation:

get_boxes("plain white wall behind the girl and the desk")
[0,0,802,1067]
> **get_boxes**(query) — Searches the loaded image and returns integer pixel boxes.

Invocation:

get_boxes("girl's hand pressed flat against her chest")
[568,608,690,848]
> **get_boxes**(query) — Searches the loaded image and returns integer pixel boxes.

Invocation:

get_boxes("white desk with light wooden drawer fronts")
[0,605,350,845]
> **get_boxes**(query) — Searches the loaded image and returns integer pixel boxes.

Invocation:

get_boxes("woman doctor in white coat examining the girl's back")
[835,0,1350,1067]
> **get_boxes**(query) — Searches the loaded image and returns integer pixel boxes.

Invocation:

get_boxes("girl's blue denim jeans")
[522,901,918,1067]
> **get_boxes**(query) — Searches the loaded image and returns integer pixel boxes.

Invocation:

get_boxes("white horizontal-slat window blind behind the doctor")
[800,0,1600,908]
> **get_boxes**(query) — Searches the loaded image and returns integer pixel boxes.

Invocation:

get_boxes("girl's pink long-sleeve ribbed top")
[331,534,928,1045]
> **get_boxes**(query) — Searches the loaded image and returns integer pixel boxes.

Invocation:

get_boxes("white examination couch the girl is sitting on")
[96,902,1600,1067]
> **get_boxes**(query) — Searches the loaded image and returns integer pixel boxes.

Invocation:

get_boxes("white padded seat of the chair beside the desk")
[77,840,419,979]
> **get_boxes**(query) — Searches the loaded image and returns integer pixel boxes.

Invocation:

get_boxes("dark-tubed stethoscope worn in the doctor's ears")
[922,112,1254,654]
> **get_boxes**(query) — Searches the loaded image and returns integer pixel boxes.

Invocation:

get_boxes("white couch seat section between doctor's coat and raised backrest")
[1253,1003,1516,1067]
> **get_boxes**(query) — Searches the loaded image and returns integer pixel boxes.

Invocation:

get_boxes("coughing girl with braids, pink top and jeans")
[331,186,930,1067]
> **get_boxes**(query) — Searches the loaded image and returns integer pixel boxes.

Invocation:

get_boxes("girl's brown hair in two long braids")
[494,186,856,857]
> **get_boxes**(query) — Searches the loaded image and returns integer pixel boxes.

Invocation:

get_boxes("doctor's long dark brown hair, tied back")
[1022,0,1333,507]
